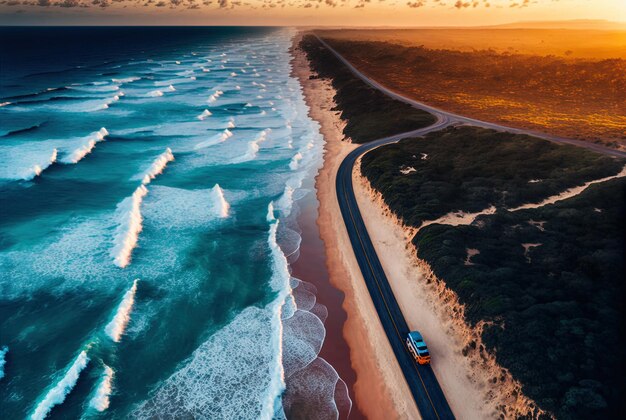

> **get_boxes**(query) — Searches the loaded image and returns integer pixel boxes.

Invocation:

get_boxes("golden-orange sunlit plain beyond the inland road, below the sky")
[319,29,626,149]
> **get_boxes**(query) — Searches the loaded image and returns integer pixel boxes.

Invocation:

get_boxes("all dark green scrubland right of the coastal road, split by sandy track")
[362,127,626,419]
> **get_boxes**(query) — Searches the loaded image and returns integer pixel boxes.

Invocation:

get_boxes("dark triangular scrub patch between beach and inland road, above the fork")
[299,35,435,143]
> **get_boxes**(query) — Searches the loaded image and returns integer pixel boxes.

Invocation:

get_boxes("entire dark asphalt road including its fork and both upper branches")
[315,35,626,419]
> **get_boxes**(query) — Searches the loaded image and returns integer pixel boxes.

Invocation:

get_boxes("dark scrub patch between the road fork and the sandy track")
[361,127,624,226]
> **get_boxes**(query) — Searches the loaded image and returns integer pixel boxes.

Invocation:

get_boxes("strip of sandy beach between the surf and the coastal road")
[292,32,420,419]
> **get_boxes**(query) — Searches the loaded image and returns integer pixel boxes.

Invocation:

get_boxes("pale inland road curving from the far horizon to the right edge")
[314,34,626,157]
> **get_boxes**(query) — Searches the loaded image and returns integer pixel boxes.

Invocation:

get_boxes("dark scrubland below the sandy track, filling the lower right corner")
[413,178,626,419]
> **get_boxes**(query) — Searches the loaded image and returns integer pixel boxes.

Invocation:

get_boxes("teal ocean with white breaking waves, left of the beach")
[0,27,351,419]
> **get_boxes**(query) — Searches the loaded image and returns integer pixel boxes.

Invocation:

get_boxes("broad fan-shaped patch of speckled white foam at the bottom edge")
[132,306,280,420]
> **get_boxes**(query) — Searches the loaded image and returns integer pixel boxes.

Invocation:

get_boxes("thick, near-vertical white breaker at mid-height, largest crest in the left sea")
[111,185,148,268]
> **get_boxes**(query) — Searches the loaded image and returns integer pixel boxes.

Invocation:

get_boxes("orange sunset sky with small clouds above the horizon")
[0,0,626,26]
